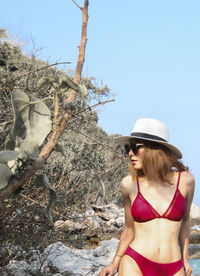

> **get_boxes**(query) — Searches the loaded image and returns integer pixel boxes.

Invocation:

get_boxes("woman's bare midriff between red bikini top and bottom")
[130,218,181,263]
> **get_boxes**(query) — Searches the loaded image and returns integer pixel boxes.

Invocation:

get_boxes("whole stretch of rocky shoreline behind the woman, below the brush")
[0,204,200,276]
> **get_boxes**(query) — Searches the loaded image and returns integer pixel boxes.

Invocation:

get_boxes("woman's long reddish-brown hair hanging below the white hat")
[129,140,188,183]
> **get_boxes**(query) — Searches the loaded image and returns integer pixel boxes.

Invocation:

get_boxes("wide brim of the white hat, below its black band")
[115,135,182,159]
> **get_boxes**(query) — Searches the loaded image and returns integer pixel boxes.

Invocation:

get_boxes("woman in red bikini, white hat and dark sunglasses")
[99,119,194,276]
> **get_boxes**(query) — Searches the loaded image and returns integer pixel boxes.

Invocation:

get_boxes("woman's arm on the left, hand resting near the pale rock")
[99,176,134,276]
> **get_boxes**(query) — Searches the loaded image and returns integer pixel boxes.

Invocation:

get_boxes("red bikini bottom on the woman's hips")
[124,246,183,276]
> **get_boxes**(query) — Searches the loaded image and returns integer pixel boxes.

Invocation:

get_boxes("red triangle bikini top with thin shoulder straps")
[131,172,186,222]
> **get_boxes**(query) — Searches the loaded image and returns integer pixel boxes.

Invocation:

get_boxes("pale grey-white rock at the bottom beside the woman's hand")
[40,239,118,276]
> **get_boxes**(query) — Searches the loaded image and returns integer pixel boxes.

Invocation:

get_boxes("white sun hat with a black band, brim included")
[115,118,182,159]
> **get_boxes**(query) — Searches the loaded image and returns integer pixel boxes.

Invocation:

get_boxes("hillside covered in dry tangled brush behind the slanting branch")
[0,31,127,266]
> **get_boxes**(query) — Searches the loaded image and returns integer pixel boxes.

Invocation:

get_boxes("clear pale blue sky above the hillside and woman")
[0,0,200,205]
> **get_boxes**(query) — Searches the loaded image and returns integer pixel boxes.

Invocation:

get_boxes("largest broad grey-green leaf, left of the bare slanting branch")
[6,90,52,159]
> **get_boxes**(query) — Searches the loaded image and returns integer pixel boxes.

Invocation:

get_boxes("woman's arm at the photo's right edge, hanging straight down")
[179,173,195,272]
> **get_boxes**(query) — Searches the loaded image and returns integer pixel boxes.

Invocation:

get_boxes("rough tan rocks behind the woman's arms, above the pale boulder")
[54,204,200,249]
